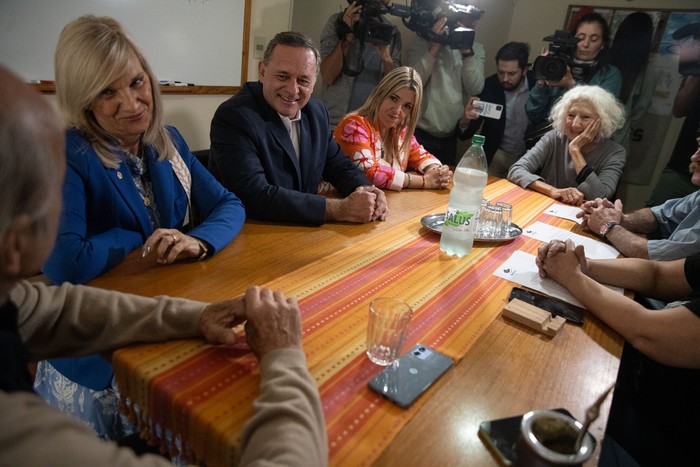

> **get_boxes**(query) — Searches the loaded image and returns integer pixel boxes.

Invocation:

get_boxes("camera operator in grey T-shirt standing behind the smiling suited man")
[320,0,401,127]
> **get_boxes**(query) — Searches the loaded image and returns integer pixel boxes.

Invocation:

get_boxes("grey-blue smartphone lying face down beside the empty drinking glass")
[368,344,454,408]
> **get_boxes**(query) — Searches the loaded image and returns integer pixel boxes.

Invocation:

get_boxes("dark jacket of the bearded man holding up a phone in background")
[457,71,536,164]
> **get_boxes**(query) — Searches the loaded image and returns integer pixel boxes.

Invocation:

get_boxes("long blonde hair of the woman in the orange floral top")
[355,66,423,164]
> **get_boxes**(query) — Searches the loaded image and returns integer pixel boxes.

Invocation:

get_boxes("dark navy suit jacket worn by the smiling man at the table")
[209,82,371,225]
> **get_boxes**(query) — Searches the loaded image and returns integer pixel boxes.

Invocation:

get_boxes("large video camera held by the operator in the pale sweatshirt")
[403,0,484,49]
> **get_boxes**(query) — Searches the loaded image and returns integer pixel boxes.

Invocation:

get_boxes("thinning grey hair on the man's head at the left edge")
[0,66,65,237]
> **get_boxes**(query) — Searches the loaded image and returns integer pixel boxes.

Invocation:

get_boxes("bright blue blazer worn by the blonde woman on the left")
[43,127,245,284]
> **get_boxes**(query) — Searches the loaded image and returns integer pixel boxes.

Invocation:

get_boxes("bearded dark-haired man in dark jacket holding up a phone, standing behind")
[457,42,535,178]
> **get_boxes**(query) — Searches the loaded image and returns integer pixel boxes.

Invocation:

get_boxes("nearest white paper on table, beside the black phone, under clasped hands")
[493,250,624,308]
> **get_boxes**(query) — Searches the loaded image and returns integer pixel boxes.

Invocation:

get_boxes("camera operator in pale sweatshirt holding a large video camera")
[408,0,486,166]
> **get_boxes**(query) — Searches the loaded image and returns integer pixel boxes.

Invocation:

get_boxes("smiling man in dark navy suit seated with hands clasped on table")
[209,32,387,225]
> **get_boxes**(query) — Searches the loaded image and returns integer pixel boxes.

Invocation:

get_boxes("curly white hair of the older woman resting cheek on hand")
[549,84,625,140]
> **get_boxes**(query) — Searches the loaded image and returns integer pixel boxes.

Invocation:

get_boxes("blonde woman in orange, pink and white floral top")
[334,66,452,190]
